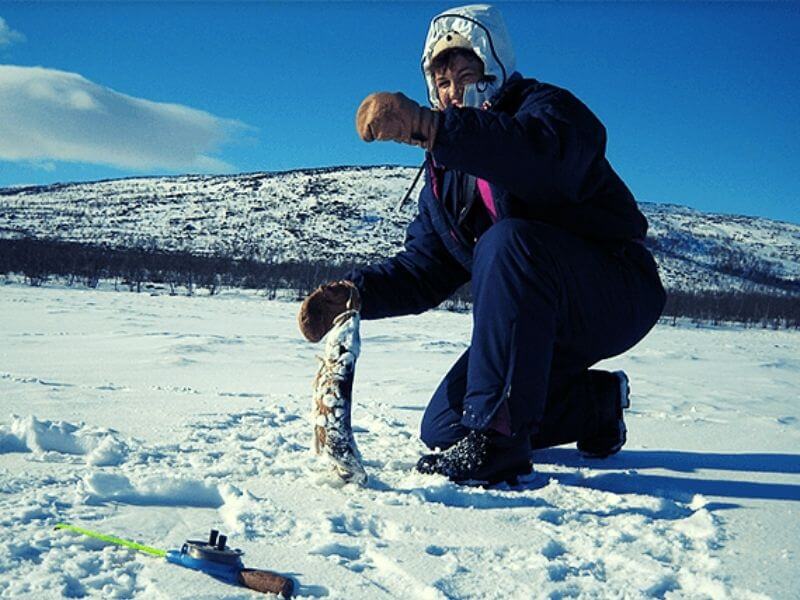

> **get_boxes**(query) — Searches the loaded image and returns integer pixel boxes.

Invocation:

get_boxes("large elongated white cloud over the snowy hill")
[0,65,248,172]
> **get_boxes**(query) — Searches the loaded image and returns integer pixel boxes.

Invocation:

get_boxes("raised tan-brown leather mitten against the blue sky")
[356,92,441,150]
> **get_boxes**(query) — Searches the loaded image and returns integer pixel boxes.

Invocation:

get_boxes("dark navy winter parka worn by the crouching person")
[346,73,647,319]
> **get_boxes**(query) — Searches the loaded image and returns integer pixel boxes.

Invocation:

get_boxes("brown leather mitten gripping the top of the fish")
[297,280,361,342]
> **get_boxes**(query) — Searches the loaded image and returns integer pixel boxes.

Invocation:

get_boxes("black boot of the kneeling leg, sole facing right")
[578,371,631,458]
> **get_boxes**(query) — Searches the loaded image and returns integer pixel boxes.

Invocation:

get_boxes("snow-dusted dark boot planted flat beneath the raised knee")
[417,430,533,485]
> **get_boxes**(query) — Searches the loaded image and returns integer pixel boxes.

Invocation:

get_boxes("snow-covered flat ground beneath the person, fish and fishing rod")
[0,284,800,599]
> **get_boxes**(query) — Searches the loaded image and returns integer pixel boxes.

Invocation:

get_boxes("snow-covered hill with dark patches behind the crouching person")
[0,166,800,293]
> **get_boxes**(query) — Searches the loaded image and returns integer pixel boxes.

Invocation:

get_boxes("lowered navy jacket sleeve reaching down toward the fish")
[344,189,469,319]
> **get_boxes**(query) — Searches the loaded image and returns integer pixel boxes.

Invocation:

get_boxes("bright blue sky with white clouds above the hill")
[0,2,800,223]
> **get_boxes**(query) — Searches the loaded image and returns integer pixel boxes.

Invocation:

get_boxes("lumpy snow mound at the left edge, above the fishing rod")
[0,415,129,467]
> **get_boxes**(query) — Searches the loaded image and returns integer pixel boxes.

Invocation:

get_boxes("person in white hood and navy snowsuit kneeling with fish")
[300,5,665,483]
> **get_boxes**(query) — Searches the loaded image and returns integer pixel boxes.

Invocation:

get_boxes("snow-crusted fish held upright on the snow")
[313,310,367,485]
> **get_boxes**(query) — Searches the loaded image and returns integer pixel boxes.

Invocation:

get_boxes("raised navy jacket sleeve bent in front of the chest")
[433,89,606,203]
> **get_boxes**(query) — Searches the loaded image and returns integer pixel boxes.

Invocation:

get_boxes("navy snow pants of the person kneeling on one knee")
[421,219,666,449]
